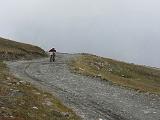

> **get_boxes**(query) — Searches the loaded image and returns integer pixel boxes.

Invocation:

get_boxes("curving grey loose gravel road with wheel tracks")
[7,53,160,120]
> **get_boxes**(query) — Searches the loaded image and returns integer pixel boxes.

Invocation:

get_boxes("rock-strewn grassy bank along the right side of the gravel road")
[71,54,160,93]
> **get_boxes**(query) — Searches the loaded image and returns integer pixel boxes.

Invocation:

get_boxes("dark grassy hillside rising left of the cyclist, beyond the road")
[0,38,46,60]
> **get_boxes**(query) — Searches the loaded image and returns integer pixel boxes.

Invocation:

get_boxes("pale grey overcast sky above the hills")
[0,0,160,67]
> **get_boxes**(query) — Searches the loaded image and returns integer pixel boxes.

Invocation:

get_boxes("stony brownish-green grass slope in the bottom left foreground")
[0,62,80,120]
